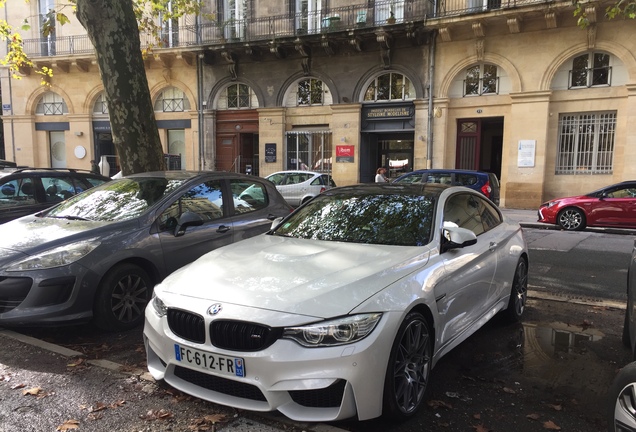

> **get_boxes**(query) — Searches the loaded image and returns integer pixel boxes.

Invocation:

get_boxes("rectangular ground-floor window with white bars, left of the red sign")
[286,131,332,172]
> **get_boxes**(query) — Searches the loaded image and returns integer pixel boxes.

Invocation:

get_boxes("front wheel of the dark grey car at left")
[94,264,153,331]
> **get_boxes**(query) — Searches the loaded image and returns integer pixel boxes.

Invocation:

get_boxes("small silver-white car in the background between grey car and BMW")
[265,171,336,207]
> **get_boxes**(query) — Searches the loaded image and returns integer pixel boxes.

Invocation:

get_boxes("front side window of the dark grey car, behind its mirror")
[159,180,223,231]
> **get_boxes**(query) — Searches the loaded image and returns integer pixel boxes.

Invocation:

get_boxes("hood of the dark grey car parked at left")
[0,216,108,258]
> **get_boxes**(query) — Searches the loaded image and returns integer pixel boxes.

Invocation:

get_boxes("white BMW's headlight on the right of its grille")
[283,313,382,348]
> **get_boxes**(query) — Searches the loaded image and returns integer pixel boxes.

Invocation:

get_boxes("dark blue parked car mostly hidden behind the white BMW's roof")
[393,169,500,205]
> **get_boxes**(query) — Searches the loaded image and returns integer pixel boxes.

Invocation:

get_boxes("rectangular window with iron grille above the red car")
[556,112,616,174]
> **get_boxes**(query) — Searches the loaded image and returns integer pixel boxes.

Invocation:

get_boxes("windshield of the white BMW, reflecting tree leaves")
[271,192,435,246]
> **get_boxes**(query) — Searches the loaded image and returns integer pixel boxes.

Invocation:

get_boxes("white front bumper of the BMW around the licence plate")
[144,305,401,421]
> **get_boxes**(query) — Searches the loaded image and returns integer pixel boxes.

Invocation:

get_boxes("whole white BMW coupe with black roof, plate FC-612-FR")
[144,184,528,421]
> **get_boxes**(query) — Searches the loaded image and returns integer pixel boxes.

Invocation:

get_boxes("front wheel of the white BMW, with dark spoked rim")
[383,312,433,420]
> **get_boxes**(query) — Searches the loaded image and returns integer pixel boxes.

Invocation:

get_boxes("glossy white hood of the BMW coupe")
[156,234,430,318]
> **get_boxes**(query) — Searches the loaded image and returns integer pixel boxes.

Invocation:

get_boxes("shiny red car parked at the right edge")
[538,180,636,231]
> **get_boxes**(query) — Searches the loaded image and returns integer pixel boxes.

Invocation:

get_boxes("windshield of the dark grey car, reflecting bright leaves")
[44,177,185,222]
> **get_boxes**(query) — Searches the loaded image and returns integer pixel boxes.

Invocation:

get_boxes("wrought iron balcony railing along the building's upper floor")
[18,0,553,57]
